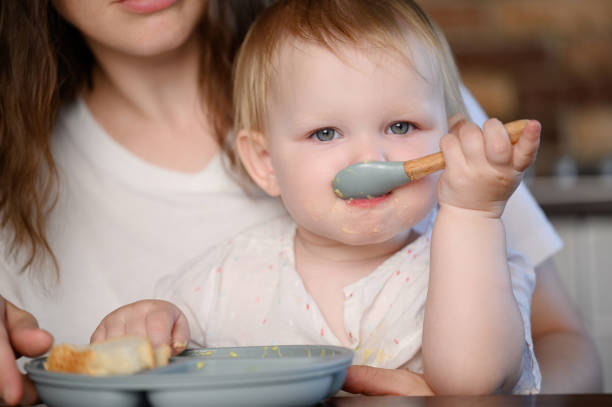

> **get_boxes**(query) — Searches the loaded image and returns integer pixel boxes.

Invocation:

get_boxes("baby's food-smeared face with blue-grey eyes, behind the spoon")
[266,44,448,245]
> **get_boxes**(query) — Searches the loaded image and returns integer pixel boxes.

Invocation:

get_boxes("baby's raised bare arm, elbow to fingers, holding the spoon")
[423,120,540,394]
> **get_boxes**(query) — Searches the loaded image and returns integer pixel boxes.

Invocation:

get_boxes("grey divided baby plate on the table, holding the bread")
[25,345,353,407]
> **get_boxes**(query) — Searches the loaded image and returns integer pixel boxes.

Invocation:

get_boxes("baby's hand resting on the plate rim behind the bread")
[91,300,189,355]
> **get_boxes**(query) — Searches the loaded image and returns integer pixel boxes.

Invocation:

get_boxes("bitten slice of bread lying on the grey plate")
[45,336,171,376]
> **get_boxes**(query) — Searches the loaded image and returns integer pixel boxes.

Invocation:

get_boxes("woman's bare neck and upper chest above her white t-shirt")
[84,35,219,172]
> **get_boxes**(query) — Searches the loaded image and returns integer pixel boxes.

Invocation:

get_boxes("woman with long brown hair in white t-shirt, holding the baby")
[0,0,600,404]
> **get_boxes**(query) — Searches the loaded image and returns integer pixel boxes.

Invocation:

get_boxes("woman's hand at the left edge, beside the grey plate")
[0,297,53,405]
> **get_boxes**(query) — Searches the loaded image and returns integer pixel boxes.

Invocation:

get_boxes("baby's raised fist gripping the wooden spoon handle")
[438,119,541,218]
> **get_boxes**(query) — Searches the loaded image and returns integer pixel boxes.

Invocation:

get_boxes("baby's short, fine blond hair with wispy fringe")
[227,0,466,182]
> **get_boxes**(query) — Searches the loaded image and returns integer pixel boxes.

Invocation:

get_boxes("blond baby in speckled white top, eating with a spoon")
[92,0,540,394]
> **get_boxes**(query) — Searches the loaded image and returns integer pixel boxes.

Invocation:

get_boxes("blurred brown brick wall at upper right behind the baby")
[419,0,612,175]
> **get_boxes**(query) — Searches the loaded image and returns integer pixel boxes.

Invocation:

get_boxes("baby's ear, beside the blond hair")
[236,130,280,196]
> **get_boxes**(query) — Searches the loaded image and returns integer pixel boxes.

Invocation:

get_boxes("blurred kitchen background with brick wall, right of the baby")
[419,0,612,392]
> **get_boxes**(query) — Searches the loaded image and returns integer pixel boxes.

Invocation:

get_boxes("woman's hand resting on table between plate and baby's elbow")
[342,366,434,396]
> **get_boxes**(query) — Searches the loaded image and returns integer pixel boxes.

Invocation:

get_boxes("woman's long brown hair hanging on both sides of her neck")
[0,0,266,275]
